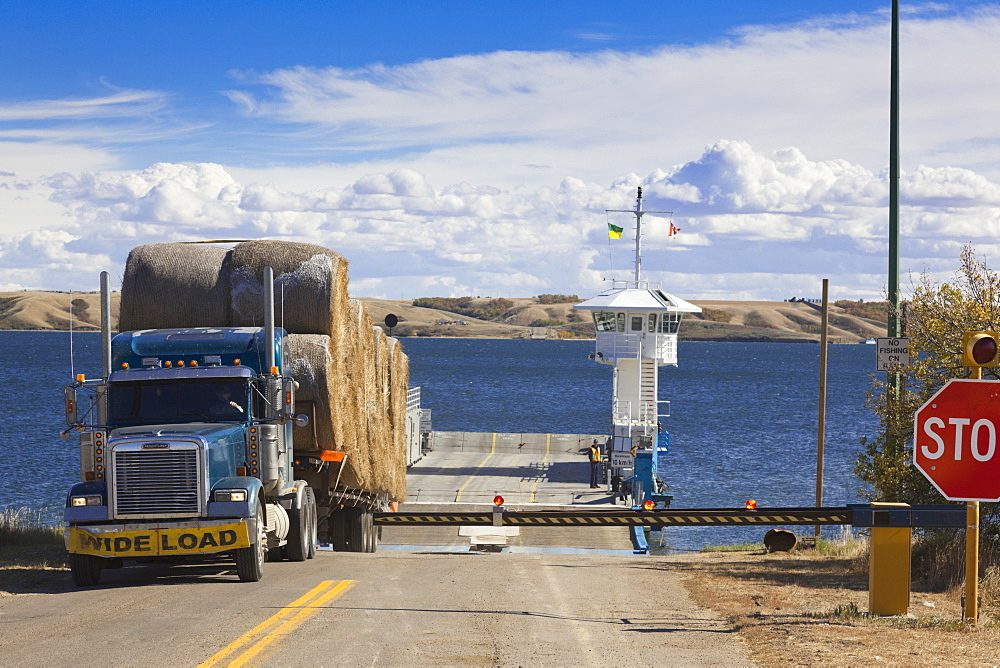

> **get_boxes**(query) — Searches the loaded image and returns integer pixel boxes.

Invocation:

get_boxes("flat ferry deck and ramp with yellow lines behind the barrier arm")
[380,431,633,554]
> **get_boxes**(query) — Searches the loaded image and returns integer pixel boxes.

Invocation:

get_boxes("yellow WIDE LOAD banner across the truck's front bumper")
[66,522,250,557]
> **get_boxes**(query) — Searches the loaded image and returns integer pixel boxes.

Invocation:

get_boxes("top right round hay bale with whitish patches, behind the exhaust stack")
[229,241,347,335]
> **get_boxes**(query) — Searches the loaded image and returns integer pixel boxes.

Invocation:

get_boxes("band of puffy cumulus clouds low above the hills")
[0,141,1000,299]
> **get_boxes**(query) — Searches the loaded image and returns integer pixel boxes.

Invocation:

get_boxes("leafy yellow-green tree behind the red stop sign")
[855,245,1000,535]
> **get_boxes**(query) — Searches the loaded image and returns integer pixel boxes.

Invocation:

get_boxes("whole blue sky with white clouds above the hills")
[0,0,1000,300]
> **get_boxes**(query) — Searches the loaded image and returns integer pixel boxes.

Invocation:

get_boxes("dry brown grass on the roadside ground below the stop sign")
[671,539,1000,666]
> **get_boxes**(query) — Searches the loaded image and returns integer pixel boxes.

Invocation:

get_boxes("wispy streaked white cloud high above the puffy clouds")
[221,6,1000,187]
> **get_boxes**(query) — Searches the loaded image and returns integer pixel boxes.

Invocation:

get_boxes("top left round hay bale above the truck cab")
[118,243,229,332]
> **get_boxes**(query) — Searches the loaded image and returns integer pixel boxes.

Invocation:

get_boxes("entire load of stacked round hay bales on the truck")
[119,241,406,501]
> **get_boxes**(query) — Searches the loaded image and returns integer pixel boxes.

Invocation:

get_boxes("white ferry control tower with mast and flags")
[573,188,701,508]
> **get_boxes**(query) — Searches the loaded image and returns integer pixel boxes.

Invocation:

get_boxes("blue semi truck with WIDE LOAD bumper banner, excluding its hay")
[64,268,387,586]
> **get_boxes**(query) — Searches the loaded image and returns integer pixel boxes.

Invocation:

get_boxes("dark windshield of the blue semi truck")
[108,380,247,424]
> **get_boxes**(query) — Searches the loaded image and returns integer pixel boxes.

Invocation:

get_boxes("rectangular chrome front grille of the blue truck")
[114,449,200,517]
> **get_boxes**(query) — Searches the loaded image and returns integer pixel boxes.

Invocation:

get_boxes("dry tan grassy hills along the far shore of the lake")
[0,292,885,343]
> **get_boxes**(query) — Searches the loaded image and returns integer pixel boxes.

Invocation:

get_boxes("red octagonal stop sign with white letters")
[913,380,1000,501]
